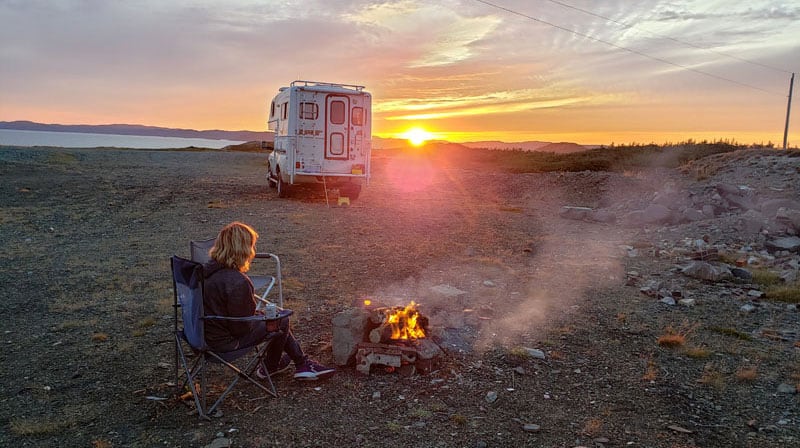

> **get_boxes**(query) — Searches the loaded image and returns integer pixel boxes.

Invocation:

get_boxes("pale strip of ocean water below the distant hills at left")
[0,129,243,149]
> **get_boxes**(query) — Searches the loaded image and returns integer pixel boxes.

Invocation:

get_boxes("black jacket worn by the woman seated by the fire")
[203,260,256,350]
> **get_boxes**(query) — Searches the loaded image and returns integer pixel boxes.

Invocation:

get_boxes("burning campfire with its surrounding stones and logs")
[333,300,442,375]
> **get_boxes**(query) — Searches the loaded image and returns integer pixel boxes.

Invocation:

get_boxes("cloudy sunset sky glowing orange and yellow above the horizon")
[0,0,800,146]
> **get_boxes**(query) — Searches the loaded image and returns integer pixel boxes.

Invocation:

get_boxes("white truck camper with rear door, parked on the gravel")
[267,81,372,199]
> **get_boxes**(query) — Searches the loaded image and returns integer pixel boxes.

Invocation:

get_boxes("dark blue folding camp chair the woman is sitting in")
[171,256,292,419]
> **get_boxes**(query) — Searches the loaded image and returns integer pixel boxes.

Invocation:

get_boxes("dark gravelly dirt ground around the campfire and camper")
[0,148,800,448]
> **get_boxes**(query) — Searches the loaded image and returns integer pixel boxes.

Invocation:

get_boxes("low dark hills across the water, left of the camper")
[0,121,273,142]
